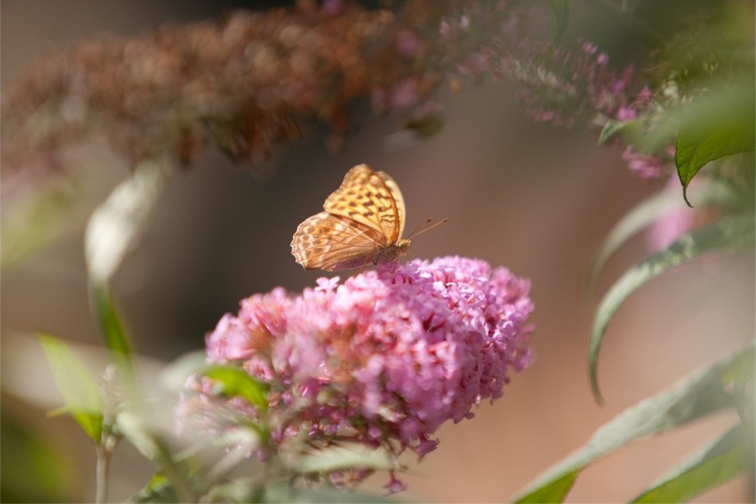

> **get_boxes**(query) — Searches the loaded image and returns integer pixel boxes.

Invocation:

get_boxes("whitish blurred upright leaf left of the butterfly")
[84,162,163,285]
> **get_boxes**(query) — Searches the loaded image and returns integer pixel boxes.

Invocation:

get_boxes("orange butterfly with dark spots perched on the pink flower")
[291,164,440,271]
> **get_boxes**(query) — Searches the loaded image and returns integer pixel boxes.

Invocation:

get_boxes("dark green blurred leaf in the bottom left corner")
[0,412,75,504]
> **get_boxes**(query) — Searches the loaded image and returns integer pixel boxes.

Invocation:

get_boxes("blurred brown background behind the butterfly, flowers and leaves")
[0,0,754,503]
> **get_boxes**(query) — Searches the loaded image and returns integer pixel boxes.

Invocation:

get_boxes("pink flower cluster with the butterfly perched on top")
[183,257,533,489]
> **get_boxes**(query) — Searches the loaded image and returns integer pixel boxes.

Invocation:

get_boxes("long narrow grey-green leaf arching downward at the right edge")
[588,214,756,402]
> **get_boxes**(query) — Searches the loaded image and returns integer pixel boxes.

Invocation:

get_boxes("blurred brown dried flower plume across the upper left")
[0,0,509,175]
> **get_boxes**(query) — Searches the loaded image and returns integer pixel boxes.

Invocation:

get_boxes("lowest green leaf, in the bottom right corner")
[631,425,748,504]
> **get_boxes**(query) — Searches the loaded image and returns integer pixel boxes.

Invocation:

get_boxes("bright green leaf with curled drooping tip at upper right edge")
[675,87,756,206]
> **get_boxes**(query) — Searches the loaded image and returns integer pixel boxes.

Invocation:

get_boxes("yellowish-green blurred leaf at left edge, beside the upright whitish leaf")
[0,181,75,271]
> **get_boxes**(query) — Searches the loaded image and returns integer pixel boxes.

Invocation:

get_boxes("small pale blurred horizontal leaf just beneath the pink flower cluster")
[297,445,396,473]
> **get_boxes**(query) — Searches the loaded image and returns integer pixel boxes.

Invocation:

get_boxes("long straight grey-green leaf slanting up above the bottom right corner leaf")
[515,343,756,504]
